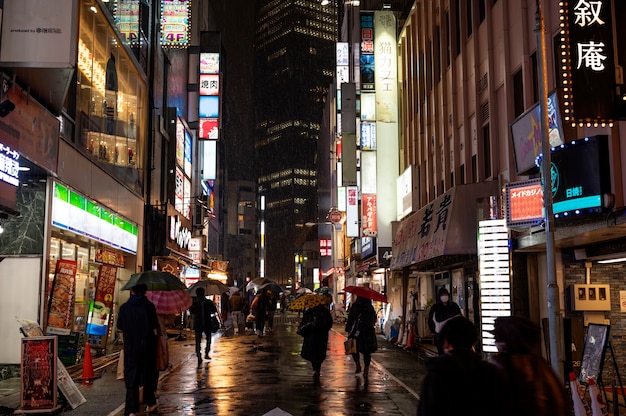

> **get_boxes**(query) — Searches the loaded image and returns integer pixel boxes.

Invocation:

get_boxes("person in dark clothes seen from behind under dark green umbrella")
[117,285,159,416]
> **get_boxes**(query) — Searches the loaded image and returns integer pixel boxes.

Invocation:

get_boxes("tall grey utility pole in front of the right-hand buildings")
[535,0,565,380]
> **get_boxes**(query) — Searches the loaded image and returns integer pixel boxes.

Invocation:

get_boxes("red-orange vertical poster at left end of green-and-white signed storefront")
[46,259,76,335]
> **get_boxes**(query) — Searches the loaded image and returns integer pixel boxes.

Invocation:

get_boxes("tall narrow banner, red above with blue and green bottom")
[87,264,117,346]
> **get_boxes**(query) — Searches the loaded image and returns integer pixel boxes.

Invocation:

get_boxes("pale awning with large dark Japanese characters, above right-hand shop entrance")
[391,181,499,270]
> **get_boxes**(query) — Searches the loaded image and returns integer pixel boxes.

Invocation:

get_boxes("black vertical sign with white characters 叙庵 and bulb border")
[562,0,615,123]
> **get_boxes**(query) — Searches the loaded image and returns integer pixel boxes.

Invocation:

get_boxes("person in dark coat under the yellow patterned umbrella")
[298,305,333,379]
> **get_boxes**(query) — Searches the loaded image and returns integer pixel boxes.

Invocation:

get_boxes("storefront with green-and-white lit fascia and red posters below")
[46,181,139,365]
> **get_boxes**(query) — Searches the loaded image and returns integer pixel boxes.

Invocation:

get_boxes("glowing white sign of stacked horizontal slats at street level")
[478,220,511,352]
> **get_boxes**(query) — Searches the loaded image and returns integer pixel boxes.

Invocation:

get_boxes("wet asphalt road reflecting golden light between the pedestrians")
[153,317,423,416]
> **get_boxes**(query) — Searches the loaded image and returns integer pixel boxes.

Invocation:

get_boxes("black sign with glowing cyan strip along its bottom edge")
[551,136,611,218]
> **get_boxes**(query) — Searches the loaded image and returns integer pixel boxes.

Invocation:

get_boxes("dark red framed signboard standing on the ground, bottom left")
[20,336,57,410]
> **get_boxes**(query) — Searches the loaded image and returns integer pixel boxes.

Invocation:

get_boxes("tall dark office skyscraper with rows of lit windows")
[255,0,337,284]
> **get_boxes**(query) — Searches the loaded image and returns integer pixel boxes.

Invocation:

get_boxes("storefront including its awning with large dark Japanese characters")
[388,181,499,337]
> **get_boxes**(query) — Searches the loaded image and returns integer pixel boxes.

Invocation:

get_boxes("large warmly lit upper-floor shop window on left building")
[76,3,146,189]
